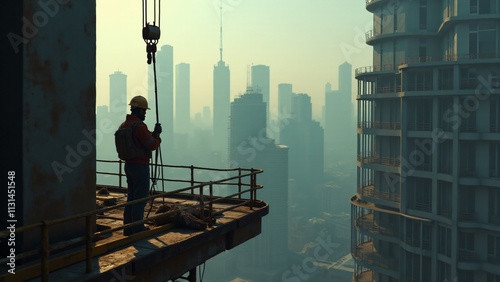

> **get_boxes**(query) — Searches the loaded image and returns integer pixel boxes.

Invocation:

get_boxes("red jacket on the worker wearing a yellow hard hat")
[120,115,161,164]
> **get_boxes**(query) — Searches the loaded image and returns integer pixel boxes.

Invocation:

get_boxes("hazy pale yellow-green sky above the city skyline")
[96,0,372,117]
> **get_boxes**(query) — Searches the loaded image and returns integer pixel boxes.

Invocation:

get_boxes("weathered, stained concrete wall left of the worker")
[19,0,96,245]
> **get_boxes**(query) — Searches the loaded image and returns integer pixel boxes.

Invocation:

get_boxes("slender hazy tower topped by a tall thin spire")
[213,5,231,162]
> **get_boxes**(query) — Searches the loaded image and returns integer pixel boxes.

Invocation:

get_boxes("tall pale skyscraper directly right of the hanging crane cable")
[155,45,174,158]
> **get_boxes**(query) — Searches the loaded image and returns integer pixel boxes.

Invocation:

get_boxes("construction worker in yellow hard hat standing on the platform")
[120,96,162,236]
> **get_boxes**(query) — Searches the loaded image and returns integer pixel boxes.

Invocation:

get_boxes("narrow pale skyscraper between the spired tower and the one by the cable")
[174,63,191,133]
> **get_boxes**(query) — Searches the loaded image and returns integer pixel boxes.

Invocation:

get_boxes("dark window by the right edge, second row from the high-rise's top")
[469,22,497,59]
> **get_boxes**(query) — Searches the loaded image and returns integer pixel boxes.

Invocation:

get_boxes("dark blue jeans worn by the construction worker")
[123,163,149,235]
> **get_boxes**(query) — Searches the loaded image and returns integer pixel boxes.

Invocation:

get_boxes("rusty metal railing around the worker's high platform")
[0,160,263,281]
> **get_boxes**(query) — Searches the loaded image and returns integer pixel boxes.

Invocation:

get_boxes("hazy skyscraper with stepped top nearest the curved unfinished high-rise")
[324,62,356,165]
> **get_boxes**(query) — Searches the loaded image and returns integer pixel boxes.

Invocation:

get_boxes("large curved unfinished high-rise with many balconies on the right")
[351,0,500,282]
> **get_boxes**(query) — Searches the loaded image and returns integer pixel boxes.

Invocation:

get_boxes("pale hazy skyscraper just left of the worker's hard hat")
[109,71,129,119]
